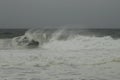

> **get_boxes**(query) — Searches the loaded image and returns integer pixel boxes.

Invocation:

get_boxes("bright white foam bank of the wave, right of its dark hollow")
[43,35,120,50]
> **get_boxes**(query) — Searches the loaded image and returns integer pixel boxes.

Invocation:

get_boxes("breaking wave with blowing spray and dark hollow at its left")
[12,29,120,50]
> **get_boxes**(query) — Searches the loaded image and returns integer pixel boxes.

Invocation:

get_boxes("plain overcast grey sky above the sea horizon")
[0,0,120,28]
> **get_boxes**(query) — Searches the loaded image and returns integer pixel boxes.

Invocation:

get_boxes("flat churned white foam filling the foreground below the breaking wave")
[0,49,120,80]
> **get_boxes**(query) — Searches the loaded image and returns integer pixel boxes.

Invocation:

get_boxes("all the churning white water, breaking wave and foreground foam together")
[0,29,120,80]
